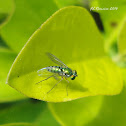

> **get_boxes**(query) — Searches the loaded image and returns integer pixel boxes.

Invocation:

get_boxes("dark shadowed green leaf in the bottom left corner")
[0,99,59,126]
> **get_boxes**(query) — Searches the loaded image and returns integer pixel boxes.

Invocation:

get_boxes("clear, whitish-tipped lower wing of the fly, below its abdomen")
[37,67,59,80]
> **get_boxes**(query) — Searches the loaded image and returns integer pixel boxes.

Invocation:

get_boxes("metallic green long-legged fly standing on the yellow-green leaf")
[36,53,77,94]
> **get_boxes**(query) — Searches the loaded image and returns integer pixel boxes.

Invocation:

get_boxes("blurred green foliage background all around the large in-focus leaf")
[0,0,126,126]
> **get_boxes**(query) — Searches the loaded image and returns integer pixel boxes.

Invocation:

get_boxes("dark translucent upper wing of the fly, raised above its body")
[46,53,68,68]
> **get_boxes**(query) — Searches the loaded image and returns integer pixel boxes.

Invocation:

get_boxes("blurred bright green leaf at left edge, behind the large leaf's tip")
[0,48,25,102]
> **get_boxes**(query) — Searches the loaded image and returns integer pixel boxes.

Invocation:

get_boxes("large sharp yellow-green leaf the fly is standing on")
[7,7,122,102]
